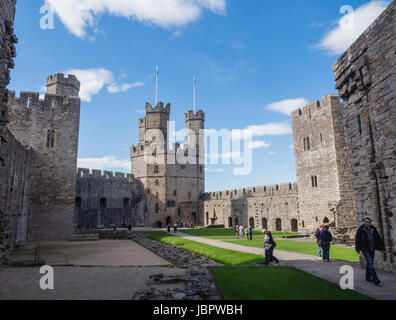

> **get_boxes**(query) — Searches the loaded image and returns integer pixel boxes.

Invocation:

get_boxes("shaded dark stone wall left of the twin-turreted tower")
[75,168,144,229]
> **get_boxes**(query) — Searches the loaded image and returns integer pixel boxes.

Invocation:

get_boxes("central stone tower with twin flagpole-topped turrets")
[131,103,205,227]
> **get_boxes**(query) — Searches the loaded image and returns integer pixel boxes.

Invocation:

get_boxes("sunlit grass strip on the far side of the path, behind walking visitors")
[226,240,359,262]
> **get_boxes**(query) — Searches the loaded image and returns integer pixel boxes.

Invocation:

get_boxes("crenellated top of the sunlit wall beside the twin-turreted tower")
[204,183,297,200]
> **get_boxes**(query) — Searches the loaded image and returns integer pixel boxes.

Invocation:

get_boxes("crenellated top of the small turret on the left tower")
[47,73,81,96]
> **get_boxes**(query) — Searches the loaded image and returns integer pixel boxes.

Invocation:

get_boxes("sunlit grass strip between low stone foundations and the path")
[142,231,264,266]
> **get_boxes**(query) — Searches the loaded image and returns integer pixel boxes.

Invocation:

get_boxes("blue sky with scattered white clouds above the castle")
[10,0,386,191]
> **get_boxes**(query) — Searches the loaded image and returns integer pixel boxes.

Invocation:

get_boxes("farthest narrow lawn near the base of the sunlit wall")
[179,228,296,240]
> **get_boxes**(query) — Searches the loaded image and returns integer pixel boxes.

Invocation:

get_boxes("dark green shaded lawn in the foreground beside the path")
[211,267,371,300]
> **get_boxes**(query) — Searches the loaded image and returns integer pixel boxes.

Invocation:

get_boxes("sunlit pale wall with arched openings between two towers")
[203,183,298,231]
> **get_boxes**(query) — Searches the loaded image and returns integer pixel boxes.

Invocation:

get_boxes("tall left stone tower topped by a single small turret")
[8,74,80,240]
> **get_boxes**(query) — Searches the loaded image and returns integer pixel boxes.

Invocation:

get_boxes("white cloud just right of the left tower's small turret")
[64,68,144,102]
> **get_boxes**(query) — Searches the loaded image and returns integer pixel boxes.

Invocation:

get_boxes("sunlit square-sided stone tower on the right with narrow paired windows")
[292,95,356,241]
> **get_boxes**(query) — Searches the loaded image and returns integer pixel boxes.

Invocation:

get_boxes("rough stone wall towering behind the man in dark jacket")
[334,1,396,270]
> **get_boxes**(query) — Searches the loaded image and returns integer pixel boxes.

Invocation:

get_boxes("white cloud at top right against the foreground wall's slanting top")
[316,1,389,55]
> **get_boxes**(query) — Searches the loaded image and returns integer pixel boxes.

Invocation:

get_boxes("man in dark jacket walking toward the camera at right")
[355,218,385,285]
